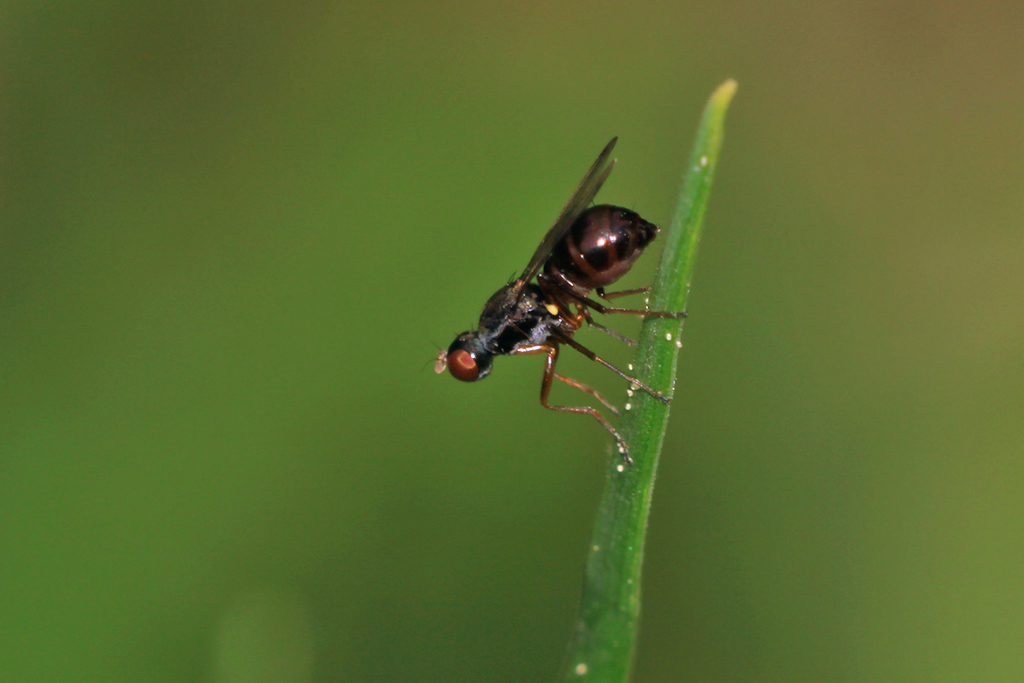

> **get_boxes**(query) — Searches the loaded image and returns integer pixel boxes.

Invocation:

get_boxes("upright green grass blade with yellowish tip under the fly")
[564,81,736,683]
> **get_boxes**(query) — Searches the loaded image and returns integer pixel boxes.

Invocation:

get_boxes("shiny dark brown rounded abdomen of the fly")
[544,204,657,293]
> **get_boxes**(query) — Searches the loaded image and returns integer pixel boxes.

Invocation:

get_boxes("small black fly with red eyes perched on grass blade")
[435,137,686,464]
